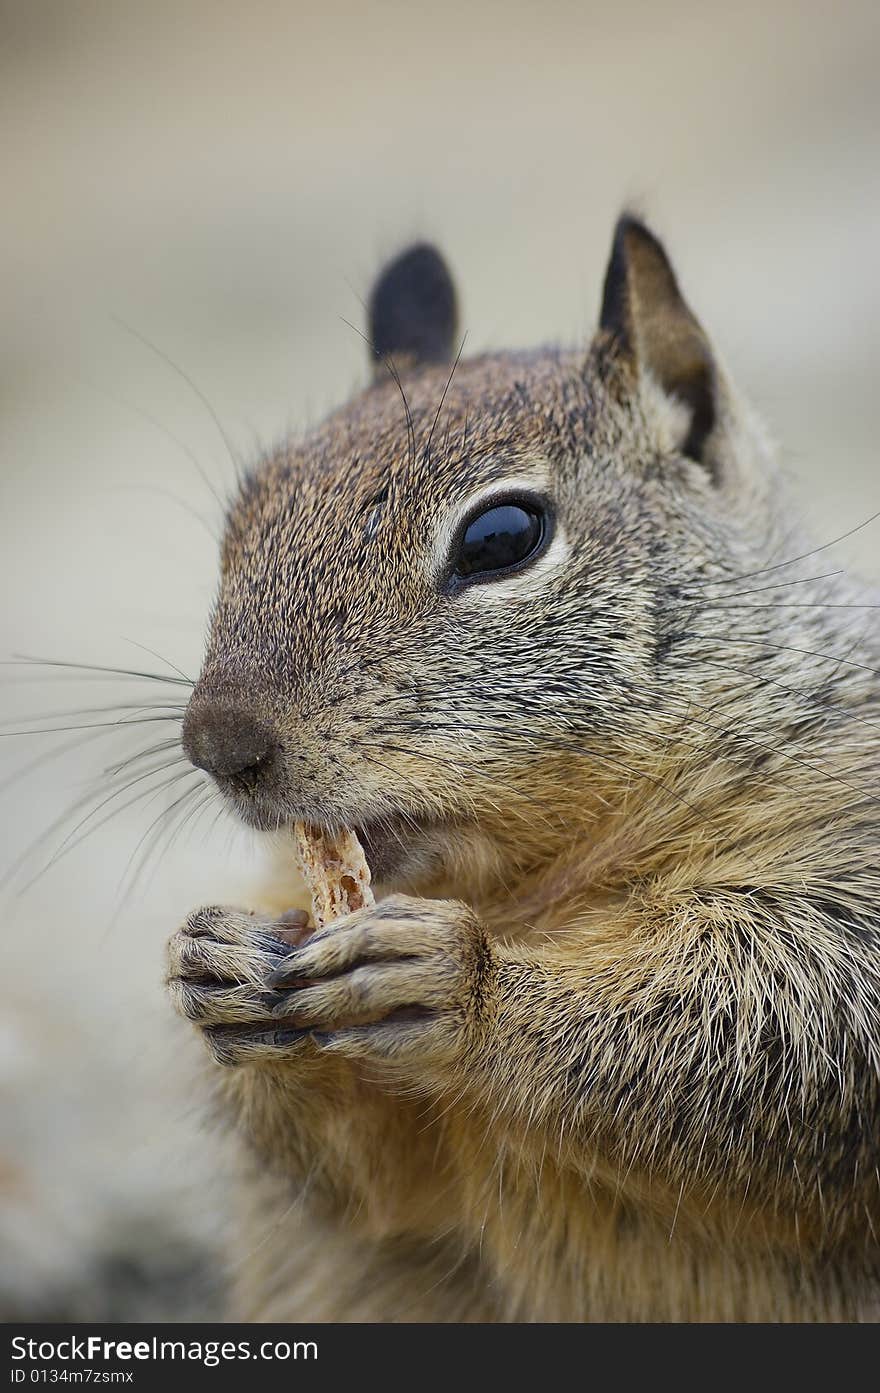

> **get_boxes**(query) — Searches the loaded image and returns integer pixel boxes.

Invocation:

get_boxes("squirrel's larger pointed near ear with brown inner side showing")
[600,215,717,462]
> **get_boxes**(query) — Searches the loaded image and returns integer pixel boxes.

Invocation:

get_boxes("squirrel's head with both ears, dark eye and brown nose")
[184,216,771,885]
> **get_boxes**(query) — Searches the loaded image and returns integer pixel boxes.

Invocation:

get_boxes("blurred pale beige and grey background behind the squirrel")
[0,0,880,1319]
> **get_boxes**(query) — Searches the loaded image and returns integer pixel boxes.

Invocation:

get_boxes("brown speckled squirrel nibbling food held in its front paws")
[168,215,880,1322]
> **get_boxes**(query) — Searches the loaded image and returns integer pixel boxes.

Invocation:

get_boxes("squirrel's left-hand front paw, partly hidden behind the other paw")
[167,907,314,1064]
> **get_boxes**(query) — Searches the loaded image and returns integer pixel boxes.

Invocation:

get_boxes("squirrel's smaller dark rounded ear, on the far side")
[368,242,458,372]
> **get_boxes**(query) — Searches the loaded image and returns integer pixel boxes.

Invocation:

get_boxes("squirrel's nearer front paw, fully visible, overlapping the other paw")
[270,894,493,1063]
